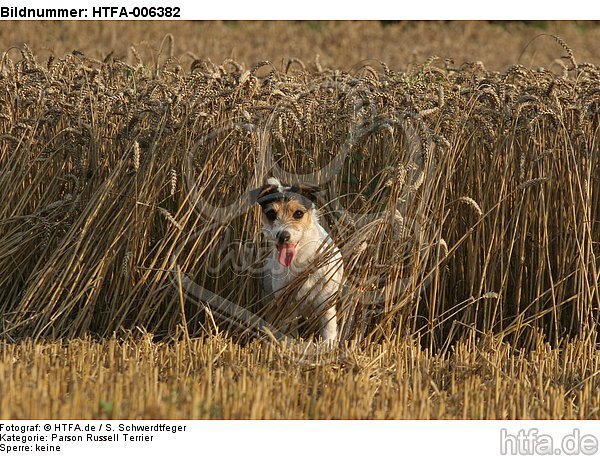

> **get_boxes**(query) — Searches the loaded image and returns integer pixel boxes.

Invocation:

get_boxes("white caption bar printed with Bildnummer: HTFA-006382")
[0,0,600,20]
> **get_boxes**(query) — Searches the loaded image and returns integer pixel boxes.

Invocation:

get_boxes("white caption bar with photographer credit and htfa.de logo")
[0,420,600,456]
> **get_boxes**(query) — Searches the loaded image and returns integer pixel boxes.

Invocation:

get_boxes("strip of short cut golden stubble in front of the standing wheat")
[0,337,600,419]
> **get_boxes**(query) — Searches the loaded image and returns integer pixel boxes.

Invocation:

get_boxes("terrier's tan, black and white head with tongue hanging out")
[250,177,319,267]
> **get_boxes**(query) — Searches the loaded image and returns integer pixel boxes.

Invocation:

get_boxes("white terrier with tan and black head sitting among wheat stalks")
[250,177,344,342]
